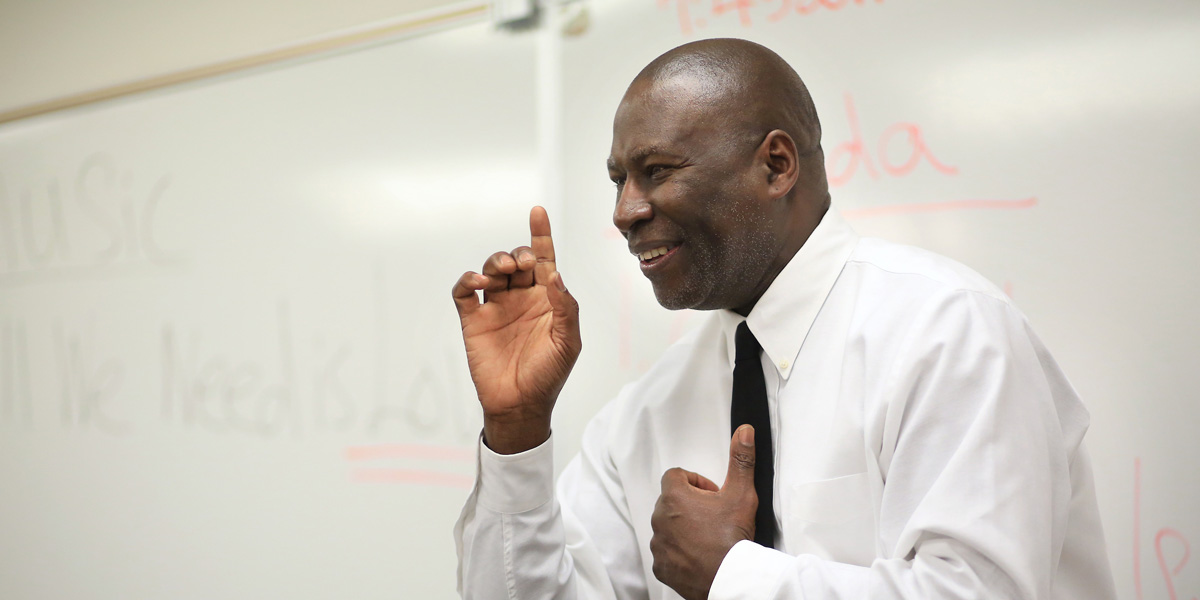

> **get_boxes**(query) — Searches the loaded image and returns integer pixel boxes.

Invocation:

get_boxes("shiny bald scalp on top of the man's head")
[626,38,823,166]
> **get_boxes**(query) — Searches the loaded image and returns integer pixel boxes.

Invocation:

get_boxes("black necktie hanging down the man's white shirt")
[730,320,775,548]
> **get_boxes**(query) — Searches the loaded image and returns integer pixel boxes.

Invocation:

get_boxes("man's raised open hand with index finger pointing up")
[452,206,583,454]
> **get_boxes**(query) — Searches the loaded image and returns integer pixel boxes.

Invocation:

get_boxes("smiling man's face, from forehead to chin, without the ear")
[608,80,780,312]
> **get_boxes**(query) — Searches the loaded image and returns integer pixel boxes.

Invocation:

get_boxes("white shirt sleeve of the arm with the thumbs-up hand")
[709,292,1111,600]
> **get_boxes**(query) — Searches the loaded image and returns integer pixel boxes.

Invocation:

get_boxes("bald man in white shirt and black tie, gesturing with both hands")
[454,40,1115,600]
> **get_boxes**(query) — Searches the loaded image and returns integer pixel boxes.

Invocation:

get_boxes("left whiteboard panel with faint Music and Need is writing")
[0,18,536,599]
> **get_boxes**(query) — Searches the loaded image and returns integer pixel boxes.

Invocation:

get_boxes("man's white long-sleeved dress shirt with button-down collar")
[455,210,1116,600]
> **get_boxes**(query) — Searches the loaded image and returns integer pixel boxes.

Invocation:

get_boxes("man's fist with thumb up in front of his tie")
[650,425,753,600]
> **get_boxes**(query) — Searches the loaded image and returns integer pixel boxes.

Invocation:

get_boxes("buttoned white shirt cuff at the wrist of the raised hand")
[478,433,554,515]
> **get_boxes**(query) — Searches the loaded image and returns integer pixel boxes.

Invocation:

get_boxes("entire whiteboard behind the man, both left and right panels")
[0,0,1200,600]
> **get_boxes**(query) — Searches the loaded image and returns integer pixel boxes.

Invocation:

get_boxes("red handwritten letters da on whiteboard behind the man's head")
[826,94,959,187]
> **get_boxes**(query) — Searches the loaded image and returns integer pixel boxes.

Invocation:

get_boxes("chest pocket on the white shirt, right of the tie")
[784,473,876,566]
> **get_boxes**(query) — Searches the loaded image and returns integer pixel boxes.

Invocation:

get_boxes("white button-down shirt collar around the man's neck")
[720,208,858,379]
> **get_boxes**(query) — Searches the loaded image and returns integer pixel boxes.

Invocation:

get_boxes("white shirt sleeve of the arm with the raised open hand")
[455,398,647,600]
